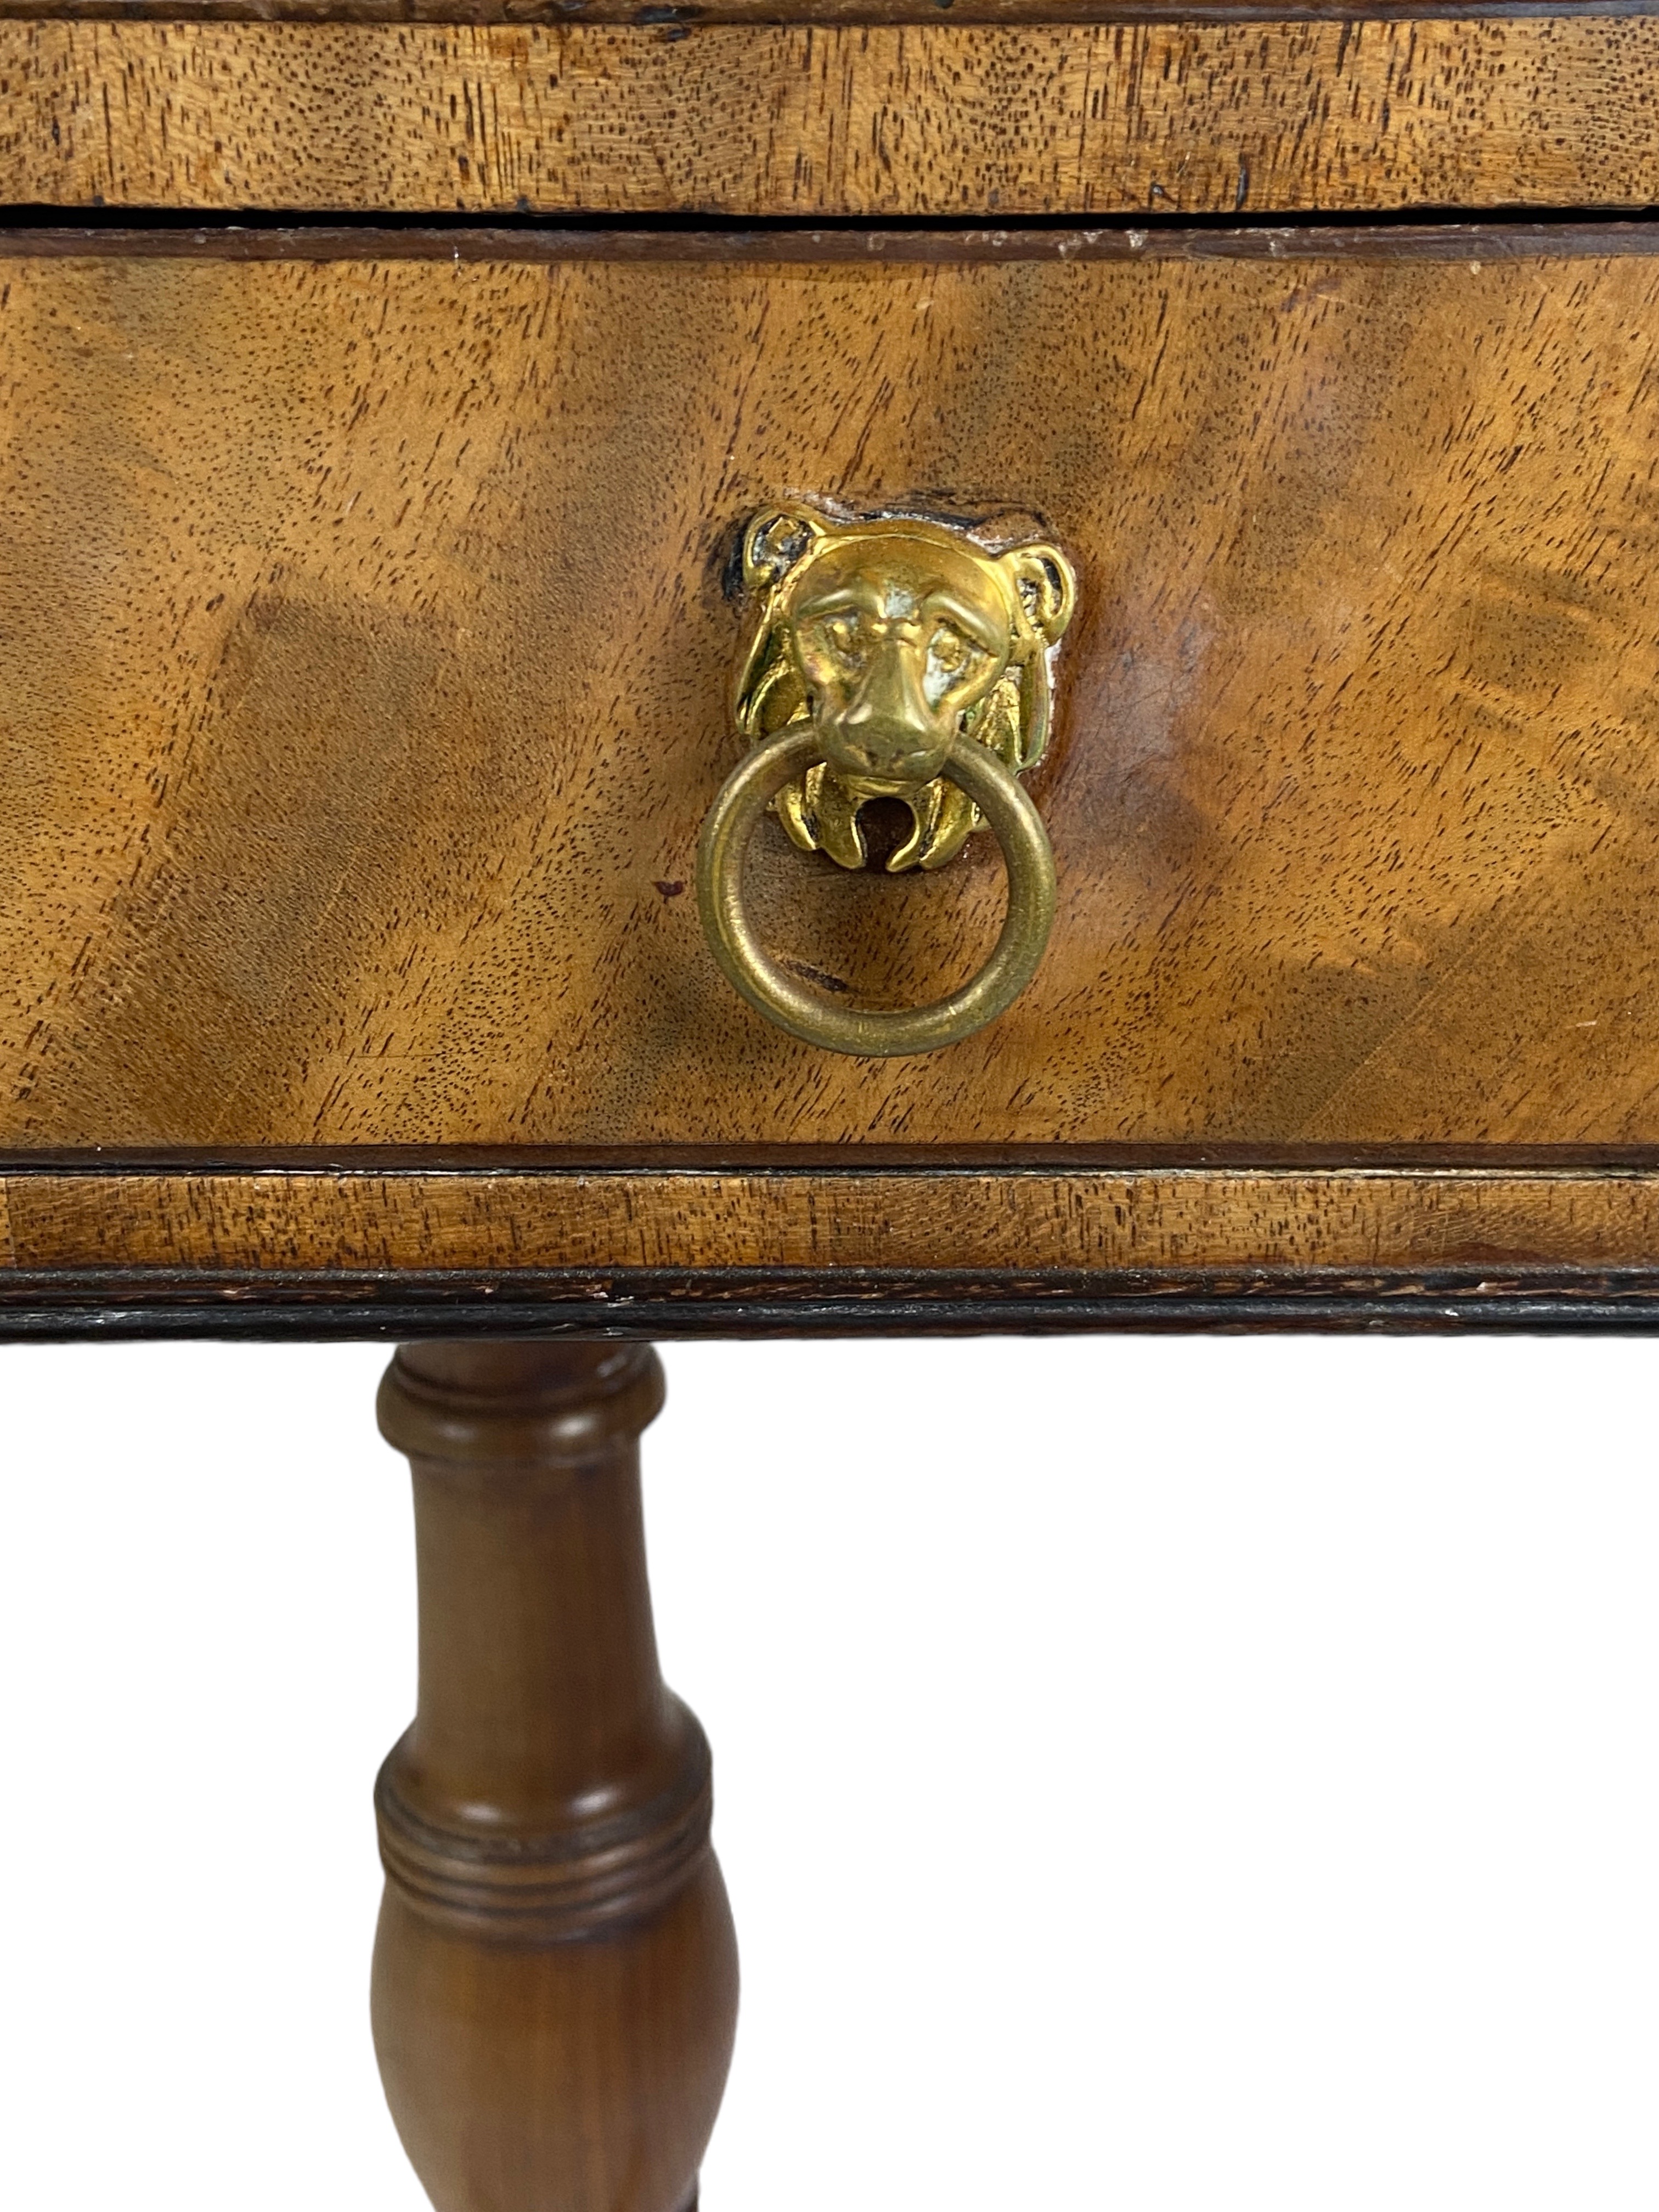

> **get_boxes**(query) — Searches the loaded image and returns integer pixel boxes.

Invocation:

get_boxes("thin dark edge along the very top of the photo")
[0,0,1659,24]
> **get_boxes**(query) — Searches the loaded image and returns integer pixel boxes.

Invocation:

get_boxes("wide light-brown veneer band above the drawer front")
[0,15,1659,217]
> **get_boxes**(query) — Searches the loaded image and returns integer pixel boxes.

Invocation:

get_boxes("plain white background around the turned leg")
[0,1338,1659,2212]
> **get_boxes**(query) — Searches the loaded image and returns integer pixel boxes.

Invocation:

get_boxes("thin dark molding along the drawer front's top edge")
[0,208,1659,268]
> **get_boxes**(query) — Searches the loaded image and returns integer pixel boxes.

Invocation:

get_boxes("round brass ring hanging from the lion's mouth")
[697,721,1055,1059]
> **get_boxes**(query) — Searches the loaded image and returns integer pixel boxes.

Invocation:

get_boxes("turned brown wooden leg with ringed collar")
[374,1342,737,2212]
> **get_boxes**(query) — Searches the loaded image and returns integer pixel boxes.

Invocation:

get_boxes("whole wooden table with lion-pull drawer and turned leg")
[0,0,1659,2212]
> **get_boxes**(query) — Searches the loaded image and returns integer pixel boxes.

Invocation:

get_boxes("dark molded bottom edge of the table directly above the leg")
[0,1265,1659,1342]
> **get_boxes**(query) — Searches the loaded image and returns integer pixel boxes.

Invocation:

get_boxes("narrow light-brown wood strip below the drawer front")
[0,1168,1659,1283]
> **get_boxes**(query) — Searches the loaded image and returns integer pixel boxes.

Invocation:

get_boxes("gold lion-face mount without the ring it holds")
[737,506,1077,872]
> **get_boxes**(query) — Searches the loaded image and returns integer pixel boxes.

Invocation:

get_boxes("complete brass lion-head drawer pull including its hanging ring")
[697,506,1075,1055]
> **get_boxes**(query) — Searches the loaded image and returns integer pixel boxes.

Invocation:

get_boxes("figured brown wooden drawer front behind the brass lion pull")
[0,228,1659,1157]
